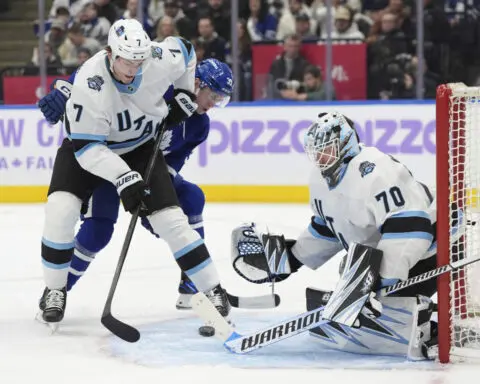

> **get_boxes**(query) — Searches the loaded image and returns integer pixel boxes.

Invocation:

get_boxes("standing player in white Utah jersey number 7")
[39,19,230,323]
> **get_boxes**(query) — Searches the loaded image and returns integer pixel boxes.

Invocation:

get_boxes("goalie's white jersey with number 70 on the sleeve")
[292,146,436,279]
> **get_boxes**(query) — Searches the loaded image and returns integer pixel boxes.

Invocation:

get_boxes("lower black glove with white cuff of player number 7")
[115,171,150,216]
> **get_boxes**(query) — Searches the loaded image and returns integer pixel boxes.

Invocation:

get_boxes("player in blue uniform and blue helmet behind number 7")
[39,59,233,309]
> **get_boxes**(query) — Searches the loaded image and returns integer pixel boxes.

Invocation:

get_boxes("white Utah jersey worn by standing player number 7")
[66,37,196,182]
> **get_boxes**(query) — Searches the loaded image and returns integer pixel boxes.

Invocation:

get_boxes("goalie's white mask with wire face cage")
[304,112,360,188]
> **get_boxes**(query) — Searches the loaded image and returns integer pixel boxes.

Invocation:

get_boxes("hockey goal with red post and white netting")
[436,83,480,362]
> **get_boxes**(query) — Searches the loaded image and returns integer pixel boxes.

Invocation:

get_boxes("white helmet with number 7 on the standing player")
[108,19,151,60]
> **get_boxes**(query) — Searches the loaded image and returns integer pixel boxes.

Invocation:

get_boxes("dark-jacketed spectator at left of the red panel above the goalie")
[268,35,309,99]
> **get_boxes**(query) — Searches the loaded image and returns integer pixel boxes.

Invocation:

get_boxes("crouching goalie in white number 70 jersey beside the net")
[232,112,442,359]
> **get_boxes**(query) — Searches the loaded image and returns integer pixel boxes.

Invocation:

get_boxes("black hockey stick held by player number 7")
[101,122,165,343]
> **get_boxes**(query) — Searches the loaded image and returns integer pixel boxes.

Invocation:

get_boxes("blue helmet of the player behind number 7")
[195,59,234,107]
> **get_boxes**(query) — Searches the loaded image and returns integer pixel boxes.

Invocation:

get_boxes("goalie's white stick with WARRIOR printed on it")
[191,252,480,354]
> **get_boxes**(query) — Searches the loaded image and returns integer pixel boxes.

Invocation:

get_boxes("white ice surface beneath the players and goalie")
[0,204,480,384]
